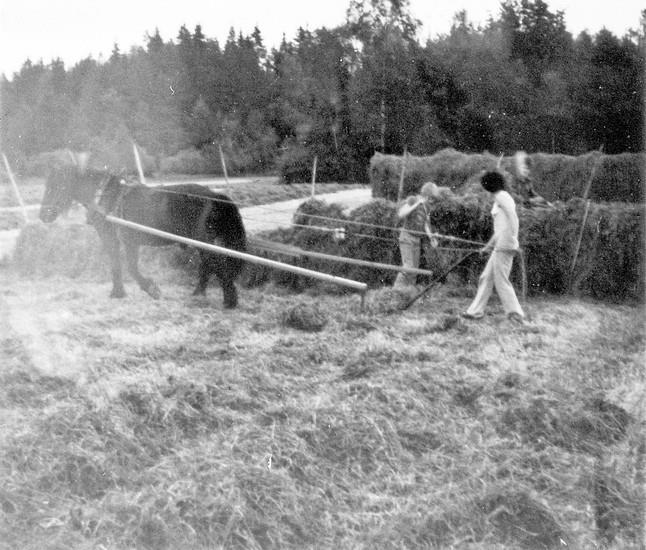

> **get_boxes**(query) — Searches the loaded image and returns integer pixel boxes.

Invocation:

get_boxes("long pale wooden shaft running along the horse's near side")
[105,216,368,293]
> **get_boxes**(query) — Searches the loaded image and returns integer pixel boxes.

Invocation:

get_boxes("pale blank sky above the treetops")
[0,0,646,78]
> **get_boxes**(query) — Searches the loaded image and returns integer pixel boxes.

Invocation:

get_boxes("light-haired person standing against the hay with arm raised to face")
[395,181,439,287]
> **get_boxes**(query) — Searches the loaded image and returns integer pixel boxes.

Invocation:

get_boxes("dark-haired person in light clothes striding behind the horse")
[462,171,525,323]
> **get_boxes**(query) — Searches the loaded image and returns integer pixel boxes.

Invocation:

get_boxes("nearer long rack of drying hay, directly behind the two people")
[256,195,645,301]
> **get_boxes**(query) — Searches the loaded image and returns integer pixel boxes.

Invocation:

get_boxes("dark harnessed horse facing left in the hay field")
[40,167,247,308]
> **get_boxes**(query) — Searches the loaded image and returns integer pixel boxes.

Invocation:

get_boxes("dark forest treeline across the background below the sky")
[0,0,646,181]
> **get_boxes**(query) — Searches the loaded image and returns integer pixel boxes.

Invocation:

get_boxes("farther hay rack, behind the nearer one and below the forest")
[369,149,646,203]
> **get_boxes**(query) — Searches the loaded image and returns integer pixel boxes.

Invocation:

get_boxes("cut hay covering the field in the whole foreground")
[0,258,646,550]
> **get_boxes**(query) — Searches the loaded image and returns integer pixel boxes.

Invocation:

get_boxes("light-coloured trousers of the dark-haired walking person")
[467,250,525,317]
